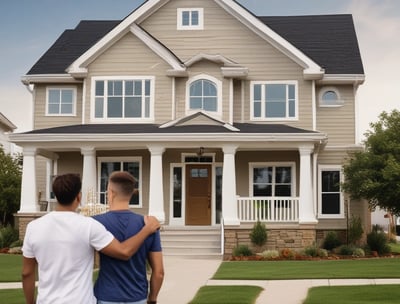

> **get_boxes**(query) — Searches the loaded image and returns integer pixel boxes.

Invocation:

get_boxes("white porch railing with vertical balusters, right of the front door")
[237,197,299,223]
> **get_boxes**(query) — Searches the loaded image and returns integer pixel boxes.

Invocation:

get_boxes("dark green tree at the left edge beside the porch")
[0,147,22,226]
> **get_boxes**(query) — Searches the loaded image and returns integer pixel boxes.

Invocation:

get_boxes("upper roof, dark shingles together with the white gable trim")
[23,0,363,81]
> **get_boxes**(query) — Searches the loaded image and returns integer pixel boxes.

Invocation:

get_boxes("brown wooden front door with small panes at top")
[186,164,211,226]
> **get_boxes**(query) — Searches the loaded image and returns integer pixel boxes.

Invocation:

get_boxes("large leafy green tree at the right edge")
[342,110,400,215]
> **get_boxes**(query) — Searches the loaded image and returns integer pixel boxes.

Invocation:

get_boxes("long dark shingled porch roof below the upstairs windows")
[25,123,318,134]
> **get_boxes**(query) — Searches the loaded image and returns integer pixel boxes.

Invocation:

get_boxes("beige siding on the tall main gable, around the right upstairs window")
[141,0,312,129]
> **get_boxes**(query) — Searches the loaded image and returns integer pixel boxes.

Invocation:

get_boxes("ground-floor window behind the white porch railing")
[250,164,294,197]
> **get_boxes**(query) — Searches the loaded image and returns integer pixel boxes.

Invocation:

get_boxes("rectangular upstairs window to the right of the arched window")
[251,81,298,120]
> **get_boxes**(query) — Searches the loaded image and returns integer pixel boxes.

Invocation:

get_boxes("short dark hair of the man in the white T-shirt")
[53,173,82,206]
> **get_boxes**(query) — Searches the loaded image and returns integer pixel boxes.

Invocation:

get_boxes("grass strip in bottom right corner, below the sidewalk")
[303,285,400,304]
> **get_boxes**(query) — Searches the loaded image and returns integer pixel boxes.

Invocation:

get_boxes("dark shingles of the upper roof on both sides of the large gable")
[27,15,364,75]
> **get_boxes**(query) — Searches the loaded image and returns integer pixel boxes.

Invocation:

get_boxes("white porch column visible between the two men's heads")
[81,147,97,205]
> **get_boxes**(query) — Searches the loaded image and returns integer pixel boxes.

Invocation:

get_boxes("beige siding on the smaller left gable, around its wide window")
[86,33,172,123]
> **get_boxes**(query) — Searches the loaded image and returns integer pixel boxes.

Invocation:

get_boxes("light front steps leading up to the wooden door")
[161,226,222,258]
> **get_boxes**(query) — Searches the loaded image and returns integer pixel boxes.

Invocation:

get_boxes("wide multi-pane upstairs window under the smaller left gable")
[94,78,154,120]
